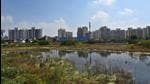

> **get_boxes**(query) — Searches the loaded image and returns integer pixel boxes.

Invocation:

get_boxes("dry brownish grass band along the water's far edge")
[2,43,150,52]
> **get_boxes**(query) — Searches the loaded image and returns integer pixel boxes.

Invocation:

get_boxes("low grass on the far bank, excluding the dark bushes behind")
[1,42,150,52]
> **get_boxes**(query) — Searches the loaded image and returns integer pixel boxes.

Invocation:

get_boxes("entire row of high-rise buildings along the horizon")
[1,22,150,42]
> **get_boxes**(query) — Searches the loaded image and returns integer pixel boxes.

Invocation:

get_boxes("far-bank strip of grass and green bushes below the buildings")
[1,37,150,52]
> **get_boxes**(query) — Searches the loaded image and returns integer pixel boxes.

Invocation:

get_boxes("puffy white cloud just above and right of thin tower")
[90,11,109,22]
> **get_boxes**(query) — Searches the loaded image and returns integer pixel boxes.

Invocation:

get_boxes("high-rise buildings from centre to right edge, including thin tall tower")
[57,25,150,43]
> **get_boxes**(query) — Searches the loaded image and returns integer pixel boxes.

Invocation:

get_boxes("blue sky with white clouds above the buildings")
[1,0,150,36]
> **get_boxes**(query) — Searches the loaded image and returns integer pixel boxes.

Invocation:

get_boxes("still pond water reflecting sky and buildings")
[32,50,150,84]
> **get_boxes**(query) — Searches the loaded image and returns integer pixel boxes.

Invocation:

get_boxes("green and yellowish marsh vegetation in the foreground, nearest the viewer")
[1,52,131,84]
